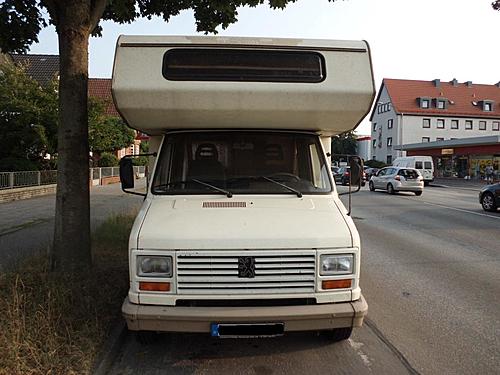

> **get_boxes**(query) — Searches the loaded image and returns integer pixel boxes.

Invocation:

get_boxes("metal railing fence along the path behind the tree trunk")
[0,166,146,190]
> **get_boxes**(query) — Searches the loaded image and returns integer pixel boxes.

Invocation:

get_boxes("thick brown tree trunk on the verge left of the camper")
[51,0,91,271]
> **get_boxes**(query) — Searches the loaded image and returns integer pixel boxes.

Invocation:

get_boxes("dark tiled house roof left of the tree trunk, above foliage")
[10,54,59,85]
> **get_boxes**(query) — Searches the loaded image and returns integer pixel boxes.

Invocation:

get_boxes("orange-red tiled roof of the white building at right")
[370,78,500,120]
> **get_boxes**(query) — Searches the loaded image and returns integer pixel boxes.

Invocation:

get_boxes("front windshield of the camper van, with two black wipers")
[152,131,332,196]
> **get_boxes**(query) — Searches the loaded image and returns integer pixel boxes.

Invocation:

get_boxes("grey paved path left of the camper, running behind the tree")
[0,181,144,271]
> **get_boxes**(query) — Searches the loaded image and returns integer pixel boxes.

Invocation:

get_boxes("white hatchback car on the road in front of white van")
[368,167,424,196]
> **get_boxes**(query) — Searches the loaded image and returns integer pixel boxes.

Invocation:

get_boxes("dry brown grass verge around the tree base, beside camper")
[0,216,133,375]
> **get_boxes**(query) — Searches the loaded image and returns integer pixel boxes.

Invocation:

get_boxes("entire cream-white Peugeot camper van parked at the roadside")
[112,36,375,340]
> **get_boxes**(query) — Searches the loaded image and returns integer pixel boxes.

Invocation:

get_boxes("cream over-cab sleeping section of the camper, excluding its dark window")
[112,36,375,136]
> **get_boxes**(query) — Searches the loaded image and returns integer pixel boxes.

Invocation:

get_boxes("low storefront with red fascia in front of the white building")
[397,136,500,180]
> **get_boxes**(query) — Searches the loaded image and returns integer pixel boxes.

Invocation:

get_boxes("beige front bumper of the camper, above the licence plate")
[122,296,368,333]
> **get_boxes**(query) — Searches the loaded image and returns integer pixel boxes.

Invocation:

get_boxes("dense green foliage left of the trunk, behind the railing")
[0,61,58,165]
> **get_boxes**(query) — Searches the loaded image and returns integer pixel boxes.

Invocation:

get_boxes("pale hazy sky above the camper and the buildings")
[30,0,500,134]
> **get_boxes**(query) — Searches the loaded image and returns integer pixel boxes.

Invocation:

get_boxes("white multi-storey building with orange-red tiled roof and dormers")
[370,79,500,164]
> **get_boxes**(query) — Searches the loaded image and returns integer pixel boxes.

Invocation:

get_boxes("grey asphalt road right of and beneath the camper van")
[110,187,500,375]
